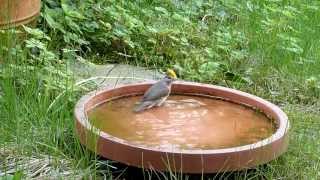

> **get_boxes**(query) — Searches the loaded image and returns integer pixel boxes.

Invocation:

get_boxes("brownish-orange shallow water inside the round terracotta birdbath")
[88,95,275,150]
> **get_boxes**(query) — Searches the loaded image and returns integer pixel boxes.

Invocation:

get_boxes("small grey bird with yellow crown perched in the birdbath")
[133,69,177,113]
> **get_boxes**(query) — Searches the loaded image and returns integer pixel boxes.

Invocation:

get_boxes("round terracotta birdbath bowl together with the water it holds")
[75,81,289,173]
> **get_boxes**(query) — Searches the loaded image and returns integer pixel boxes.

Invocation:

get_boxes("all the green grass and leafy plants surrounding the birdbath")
[0,0,320,179]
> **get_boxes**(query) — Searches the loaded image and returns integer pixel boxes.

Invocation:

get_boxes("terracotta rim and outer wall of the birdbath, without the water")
[75,82,289,173]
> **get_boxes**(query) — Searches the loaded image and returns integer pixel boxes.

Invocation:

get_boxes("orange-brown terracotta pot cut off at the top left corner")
[0,0,41,29]
